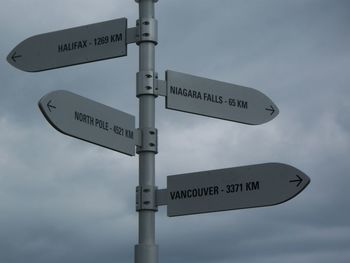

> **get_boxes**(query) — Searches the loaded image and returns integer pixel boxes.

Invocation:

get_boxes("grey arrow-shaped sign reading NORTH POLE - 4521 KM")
[39,90,135,155]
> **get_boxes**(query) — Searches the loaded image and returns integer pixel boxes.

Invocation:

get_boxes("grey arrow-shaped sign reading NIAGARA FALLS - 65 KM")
[166,70,279,125]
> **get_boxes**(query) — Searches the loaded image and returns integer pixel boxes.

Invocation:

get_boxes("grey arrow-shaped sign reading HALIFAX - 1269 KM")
[7,18,127,72]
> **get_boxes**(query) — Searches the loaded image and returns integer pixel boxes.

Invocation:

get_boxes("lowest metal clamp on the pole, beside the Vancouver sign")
[136,185,158,211]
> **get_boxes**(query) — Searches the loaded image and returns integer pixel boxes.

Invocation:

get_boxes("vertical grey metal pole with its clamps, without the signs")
[135,0,158,263]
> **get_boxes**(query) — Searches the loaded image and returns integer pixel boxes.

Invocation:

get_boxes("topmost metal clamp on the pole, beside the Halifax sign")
[136,17,158,45]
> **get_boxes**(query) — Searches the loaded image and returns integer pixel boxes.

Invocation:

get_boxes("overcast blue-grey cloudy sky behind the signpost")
[0,0,350,263]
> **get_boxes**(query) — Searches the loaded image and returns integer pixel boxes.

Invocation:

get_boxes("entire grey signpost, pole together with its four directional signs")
[7,0,310,263]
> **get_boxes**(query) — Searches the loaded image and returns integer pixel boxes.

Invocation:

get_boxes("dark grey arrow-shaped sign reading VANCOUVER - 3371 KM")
[158,163,310,216]
